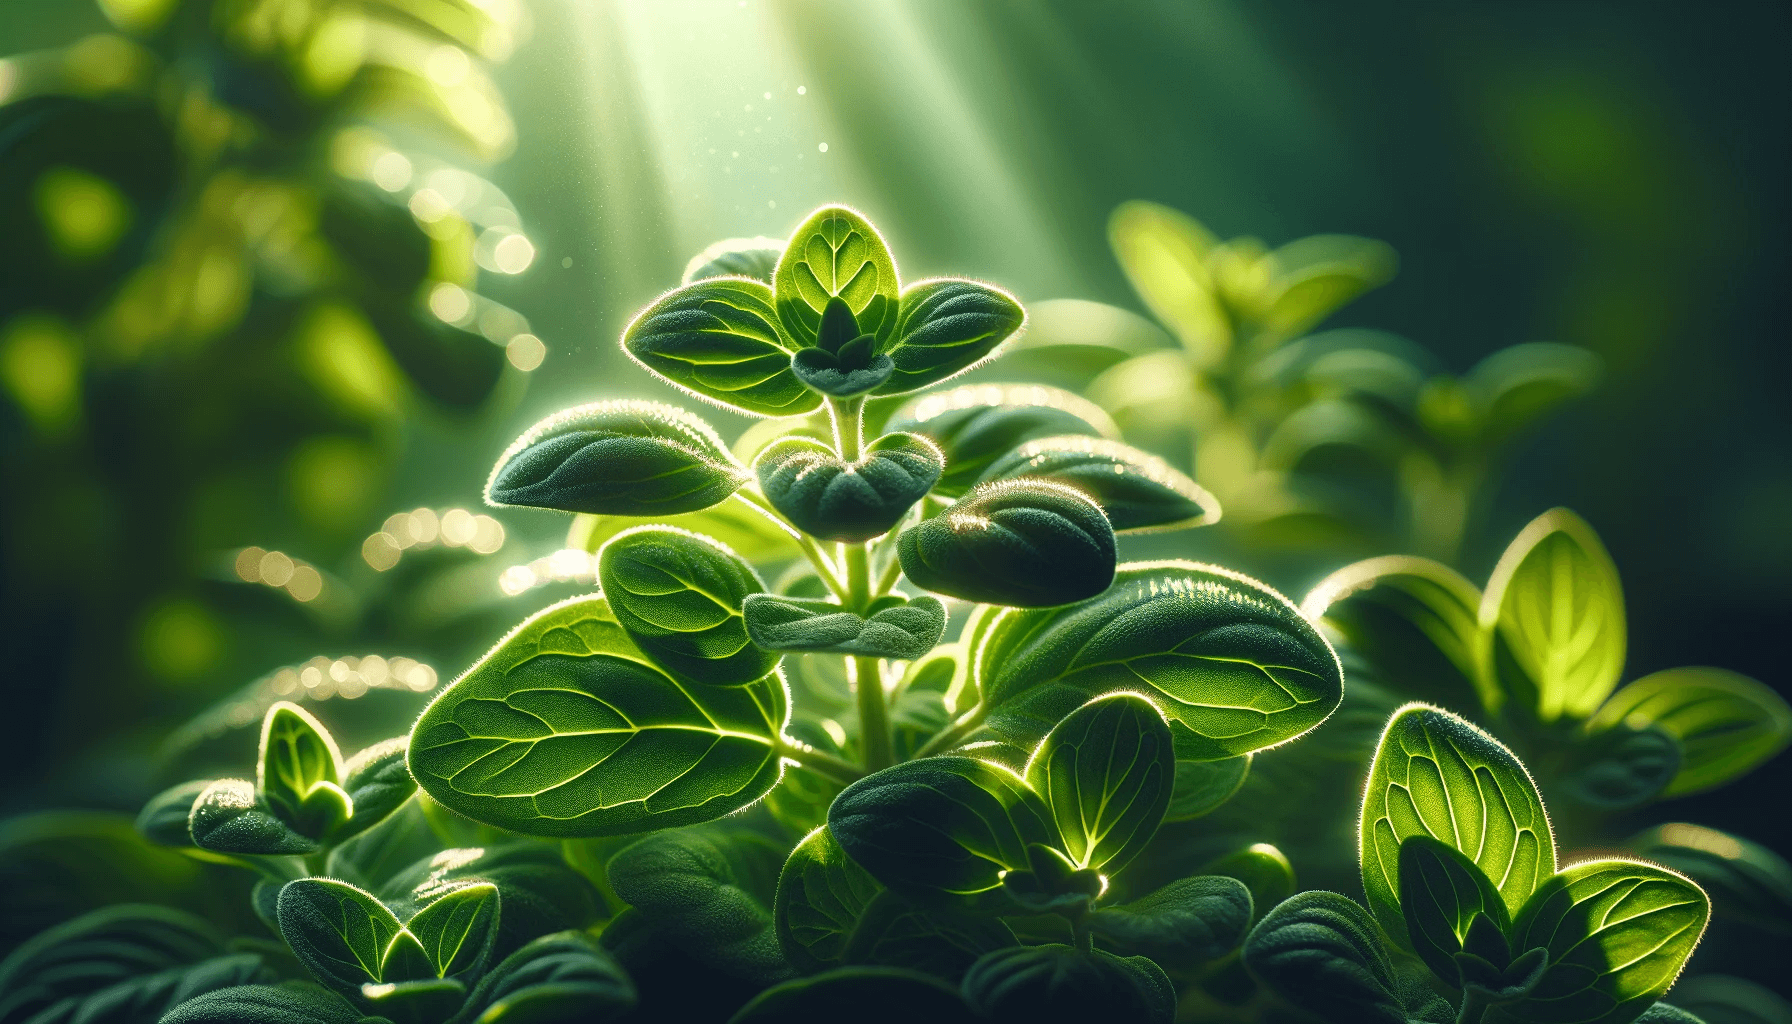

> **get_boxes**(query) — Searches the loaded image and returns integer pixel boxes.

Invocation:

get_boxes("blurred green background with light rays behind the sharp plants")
[0,0,1792,982]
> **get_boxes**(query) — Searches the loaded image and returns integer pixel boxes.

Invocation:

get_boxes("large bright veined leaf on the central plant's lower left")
[410,597,788,836]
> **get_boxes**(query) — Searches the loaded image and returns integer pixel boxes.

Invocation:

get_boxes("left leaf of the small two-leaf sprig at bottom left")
[278,879,403,997]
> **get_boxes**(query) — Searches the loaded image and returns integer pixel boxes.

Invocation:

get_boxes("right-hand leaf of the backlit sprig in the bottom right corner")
[1512,861,1711,1024]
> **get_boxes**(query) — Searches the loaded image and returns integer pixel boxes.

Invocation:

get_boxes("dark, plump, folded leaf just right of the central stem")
[896,481,1115,608]
